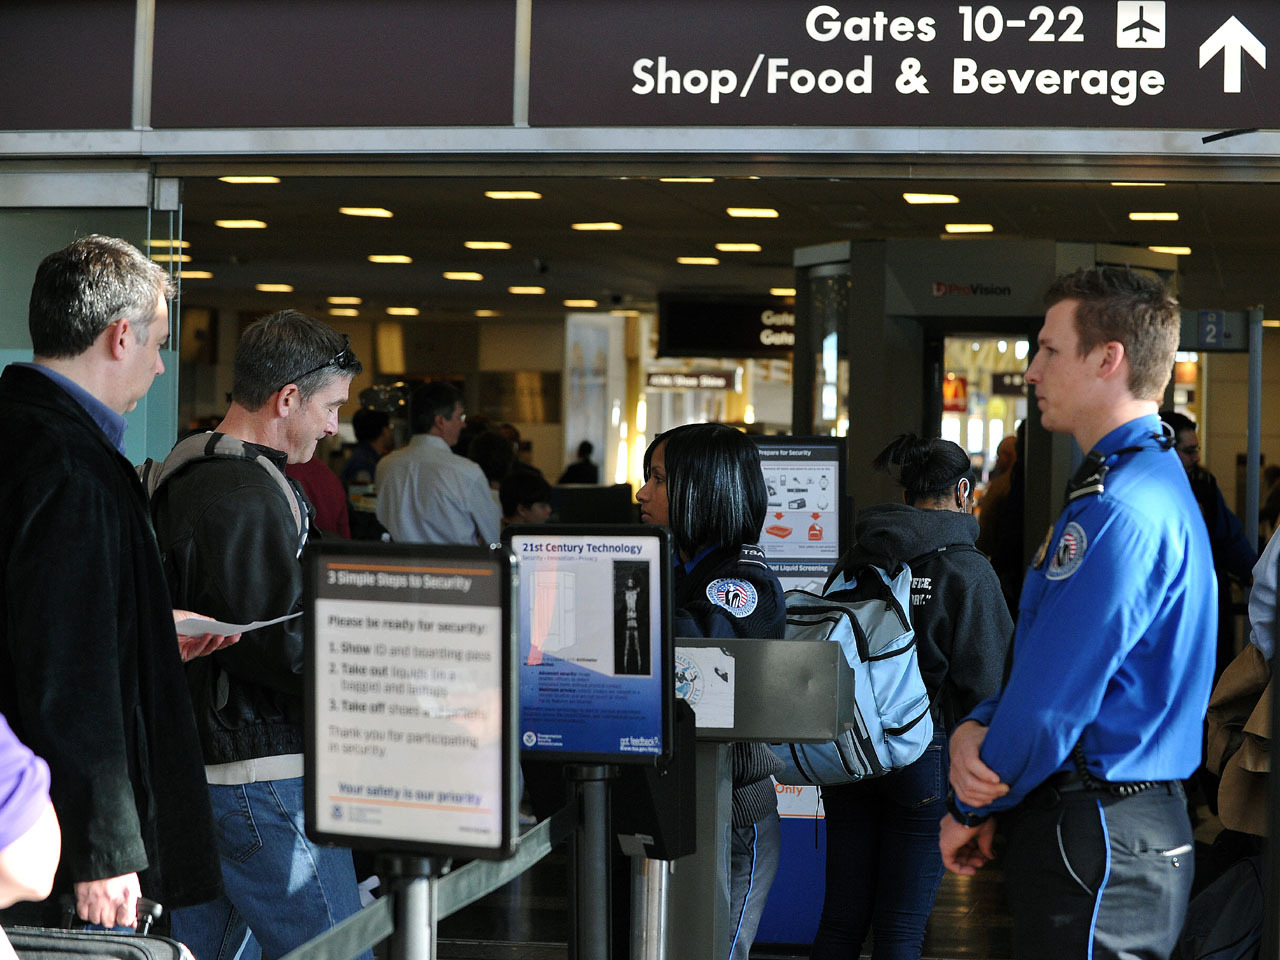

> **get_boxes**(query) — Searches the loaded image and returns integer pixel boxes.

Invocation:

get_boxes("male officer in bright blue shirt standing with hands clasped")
[940,268,1217,960]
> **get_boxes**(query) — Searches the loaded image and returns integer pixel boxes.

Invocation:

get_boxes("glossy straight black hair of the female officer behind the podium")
[644,424,769,558]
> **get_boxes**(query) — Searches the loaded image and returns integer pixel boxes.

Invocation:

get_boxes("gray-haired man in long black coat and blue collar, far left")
[0,236,220,927]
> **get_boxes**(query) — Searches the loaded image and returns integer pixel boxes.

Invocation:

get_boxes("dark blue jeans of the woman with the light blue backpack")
[809,732,947,960]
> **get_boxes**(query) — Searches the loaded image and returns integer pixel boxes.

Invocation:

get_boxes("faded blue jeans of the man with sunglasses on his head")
[173,777,372,960]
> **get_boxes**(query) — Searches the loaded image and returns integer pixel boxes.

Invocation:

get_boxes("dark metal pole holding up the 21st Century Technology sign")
[566,764,613,960]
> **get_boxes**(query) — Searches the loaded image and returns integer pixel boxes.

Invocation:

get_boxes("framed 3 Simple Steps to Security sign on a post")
[305,541,515,858]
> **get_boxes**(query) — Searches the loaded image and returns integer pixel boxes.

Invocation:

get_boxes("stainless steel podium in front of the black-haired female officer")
[668,639,854,960]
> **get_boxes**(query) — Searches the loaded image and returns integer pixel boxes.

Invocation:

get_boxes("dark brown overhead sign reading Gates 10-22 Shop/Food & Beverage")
[530,0,1280,131]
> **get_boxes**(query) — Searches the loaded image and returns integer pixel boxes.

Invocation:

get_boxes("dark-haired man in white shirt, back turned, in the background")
[378,380,500,545]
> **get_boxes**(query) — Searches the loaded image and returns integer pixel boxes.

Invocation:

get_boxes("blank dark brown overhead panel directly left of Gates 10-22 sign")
[151,0,516,128]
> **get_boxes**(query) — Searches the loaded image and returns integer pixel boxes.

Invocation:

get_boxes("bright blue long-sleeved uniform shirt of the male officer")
[960,415,1217,812]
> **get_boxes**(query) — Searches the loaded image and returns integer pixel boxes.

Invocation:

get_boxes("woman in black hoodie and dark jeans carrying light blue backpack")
[809,434,1014,960]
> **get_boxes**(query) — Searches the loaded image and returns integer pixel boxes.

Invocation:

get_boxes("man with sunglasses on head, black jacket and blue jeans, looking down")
[146,310,369,960]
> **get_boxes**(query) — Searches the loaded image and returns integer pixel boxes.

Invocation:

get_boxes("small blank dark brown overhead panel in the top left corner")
[0,0,134,131]
